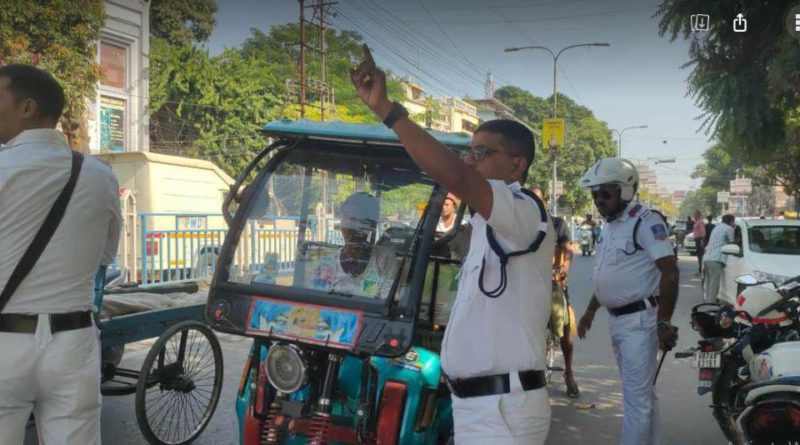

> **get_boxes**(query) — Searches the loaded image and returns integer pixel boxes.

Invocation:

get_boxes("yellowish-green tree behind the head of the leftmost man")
[0,0,105,151]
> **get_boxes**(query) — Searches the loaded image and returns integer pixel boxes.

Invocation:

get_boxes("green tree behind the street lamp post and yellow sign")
[495,86,616,215]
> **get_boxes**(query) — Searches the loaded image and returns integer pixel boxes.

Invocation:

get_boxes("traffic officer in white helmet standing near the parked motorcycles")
[578,158,678,445]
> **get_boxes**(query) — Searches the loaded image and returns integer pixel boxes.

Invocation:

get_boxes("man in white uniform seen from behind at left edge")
[0,65,120,445]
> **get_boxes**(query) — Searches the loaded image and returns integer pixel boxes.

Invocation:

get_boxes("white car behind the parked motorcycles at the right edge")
[717,219,800,304]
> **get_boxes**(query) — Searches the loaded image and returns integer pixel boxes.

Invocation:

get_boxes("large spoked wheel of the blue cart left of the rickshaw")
[136,321,223,445]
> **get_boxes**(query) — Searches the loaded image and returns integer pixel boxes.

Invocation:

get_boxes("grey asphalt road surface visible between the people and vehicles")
[26,251,726,445]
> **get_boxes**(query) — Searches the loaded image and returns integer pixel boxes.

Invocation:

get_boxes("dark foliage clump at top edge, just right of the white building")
[150,0,218,46]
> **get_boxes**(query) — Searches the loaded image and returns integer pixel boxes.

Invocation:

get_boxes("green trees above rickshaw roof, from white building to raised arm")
[150,21,402,176]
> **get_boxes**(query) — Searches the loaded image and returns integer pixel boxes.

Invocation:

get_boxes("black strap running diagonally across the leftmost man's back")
[0,151,83,312]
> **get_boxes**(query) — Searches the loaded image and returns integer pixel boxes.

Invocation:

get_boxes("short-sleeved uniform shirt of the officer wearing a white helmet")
[592,201,674,308]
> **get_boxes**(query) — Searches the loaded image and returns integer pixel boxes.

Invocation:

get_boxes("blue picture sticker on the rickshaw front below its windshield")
[247,297,363,349]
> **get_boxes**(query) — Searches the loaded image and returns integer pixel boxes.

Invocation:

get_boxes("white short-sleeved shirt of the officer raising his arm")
[442,180,555,378]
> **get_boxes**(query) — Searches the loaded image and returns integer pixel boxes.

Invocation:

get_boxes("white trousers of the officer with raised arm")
[452,373,550,445]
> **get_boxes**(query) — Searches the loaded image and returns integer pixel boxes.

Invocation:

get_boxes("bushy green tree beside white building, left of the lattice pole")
[150,39,282,176]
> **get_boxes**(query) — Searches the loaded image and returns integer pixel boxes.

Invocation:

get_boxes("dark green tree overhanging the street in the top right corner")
[656,0,800,206]
